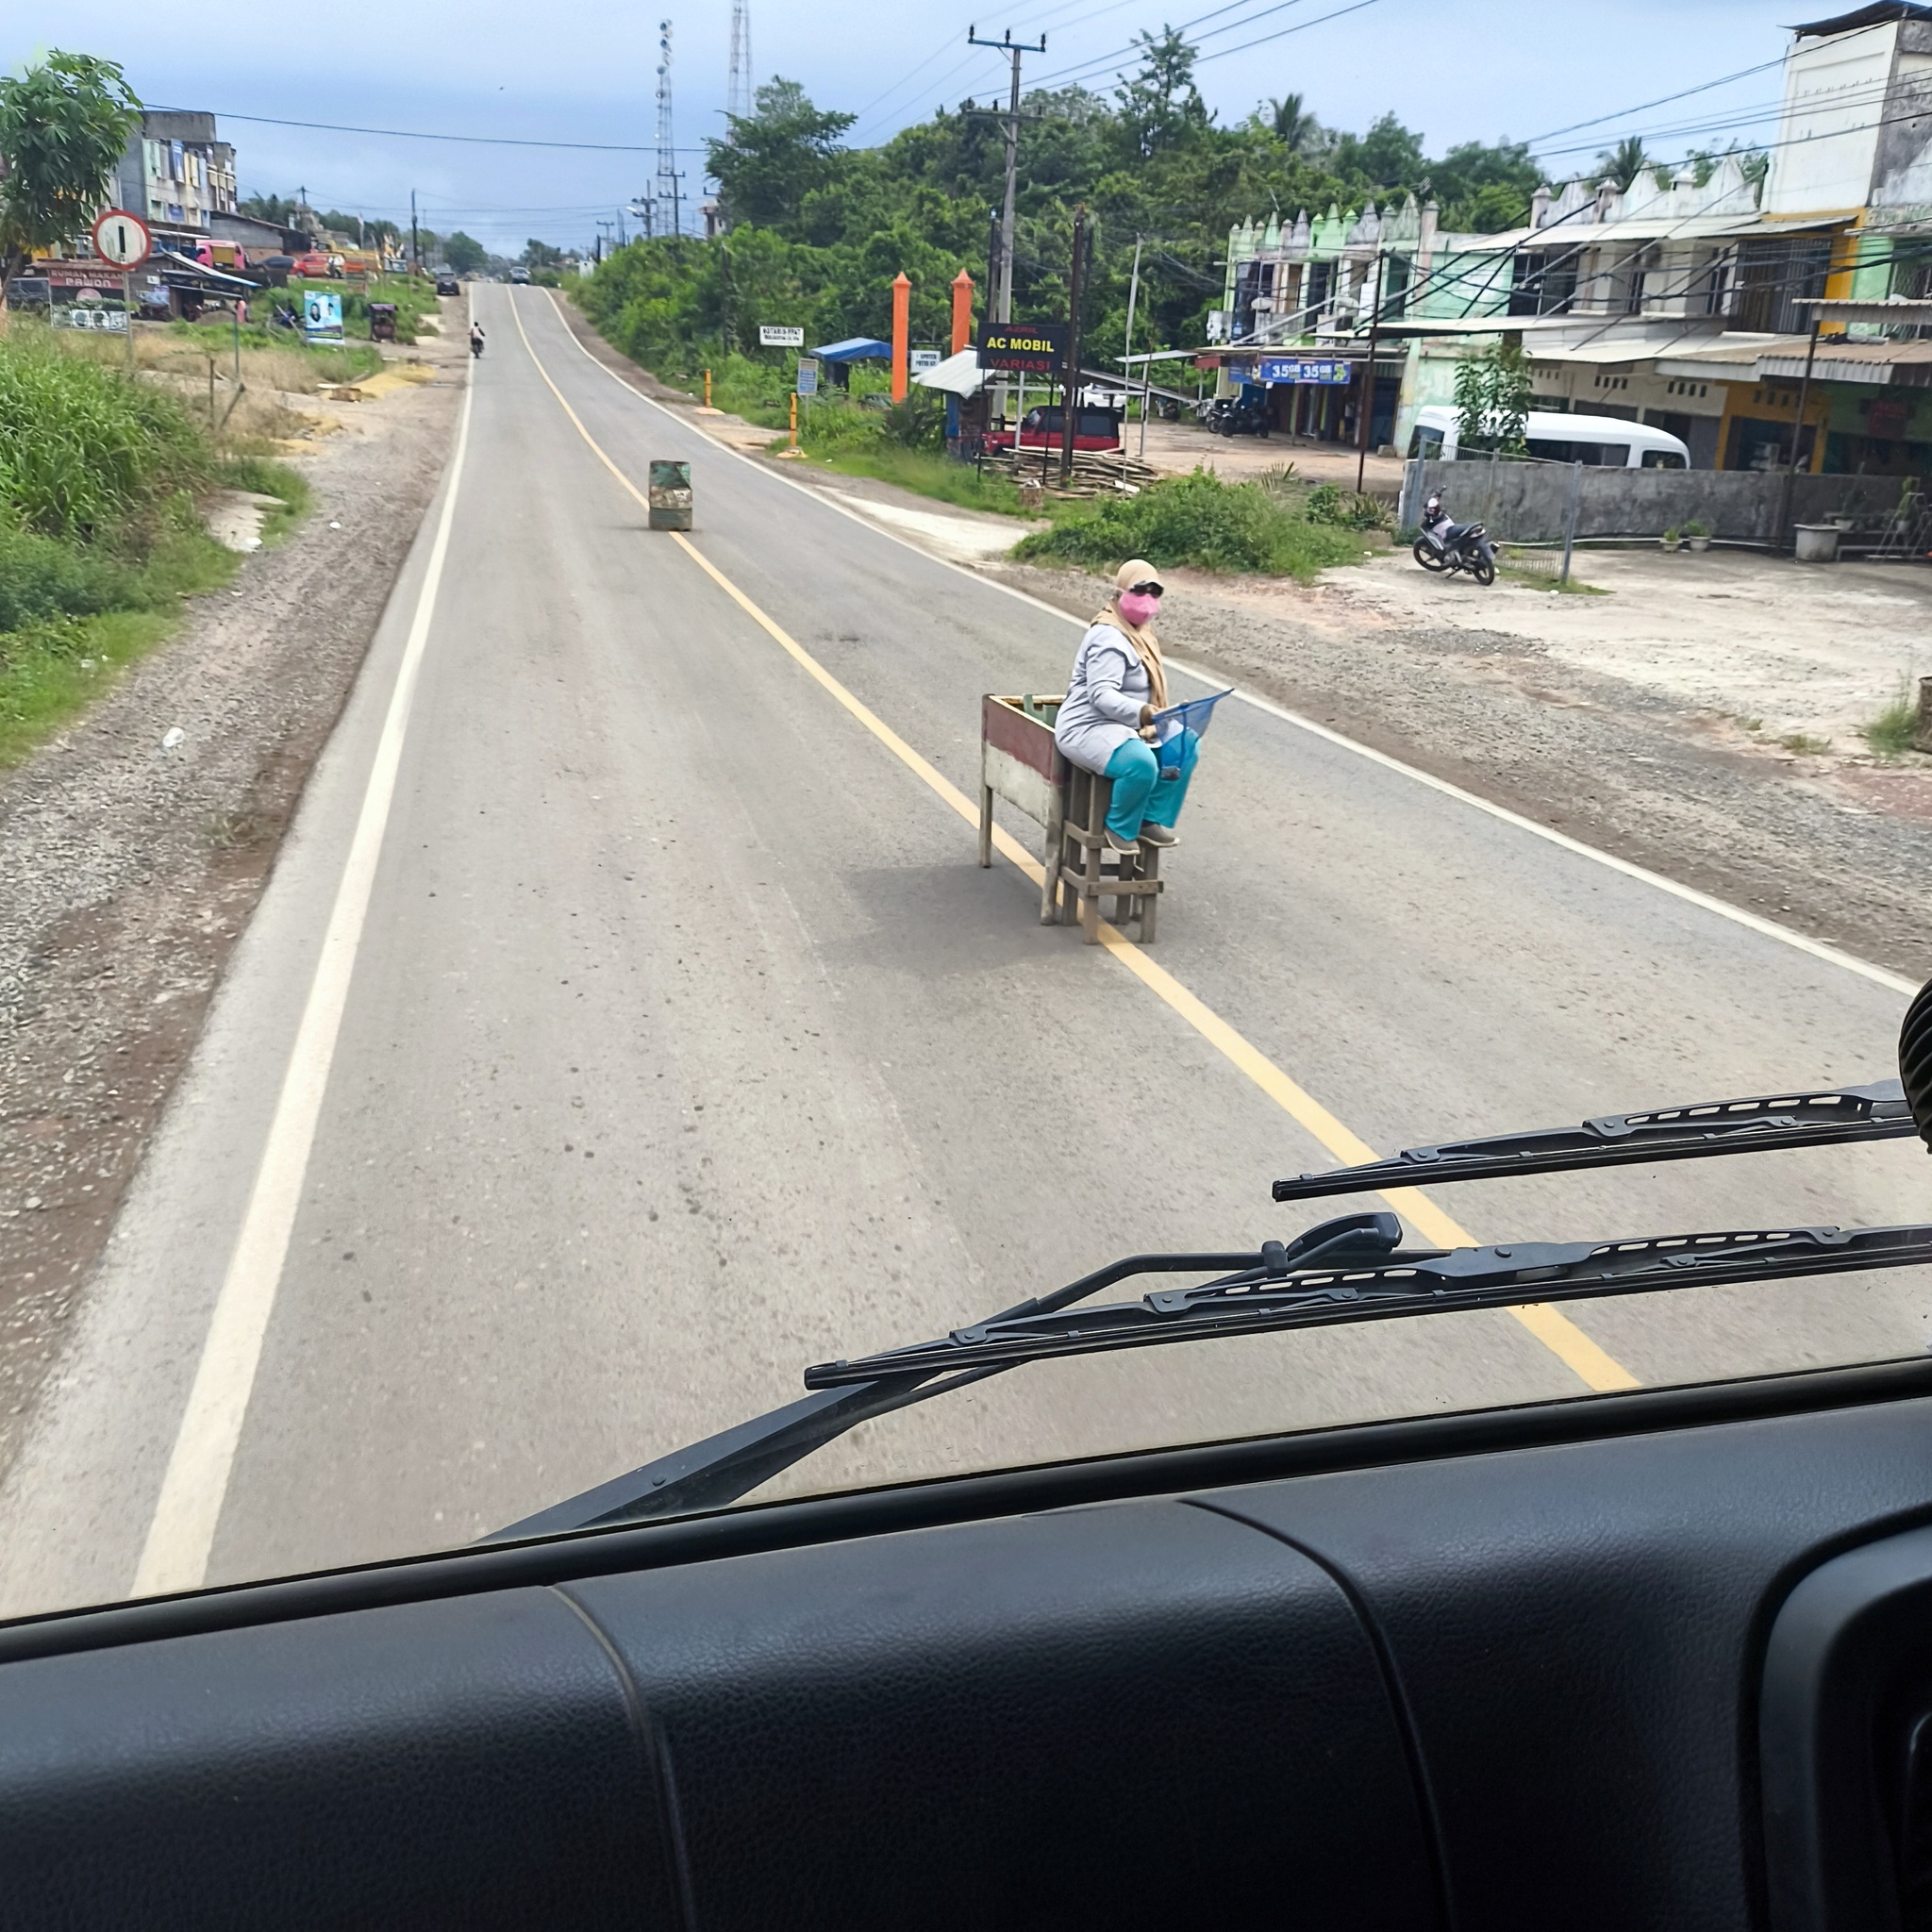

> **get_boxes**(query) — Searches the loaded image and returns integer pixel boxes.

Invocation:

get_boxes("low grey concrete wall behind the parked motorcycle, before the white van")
[1403,459,1899,542]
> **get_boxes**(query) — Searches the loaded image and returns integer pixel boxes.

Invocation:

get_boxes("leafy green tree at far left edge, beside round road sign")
[0,52,142,304]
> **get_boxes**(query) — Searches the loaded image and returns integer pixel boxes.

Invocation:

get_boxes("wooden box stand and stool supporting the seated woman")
[979,693,1161,947]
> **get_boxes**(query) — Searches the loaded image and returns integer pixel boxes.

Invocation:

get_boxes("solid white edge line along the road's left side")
[133,363,474,1596]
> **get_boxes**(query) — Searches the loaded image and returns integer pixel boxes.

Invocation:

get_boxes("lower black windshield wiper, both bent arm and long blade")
[485,1213,1932,1541]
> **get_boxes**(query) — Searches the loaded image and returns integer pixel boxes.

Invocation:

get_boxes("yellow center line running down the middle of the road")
[510,299,1641,1391]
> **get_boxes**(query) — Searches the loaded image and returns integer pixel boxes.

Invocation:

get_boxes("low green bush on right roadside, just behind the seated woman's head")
[1014,470,1362,583]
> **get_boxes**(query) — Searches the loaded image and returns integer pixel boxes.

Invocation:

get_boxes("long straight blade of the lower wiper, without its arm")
[806,1217,1932,1390]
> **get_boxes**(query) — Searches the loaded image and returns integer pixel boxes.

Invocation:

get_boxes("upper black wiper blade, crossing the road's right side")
[1275,1080,1919,1202]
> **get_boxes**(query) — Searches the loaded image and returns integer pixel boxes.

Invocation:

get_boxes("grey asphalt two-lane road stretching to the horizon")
[0,288,1928,1613]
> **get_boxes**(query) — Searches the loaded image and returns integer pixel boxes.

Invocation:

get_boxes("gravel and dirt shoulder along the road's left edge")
[0,304,466,1462]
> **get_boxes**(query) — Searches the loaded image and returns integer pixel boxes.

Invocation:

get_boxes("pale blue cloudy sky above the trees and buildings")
[18,0,1814,253]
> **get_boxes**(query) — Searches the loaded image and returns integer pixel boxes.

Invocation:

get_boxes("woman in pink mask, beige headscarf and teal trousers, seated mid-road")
[1053,557,1198,852]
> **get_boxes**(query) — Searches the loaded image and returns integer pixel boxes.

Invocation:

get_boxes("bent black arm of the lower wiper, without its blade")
[483,1213,1403,1543]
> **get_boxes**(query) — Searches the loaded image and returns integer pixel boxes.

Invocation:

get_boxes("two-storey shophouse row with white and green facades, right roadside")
[1202,0,1932,474]
